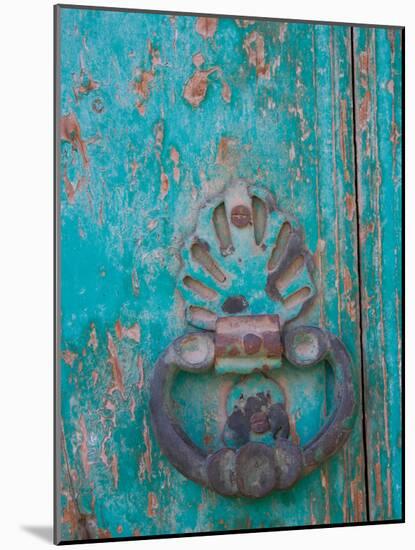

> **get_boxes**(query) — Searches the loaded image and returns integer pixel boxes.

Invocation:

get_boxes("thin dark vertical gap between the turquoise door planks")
[350,27,371,521]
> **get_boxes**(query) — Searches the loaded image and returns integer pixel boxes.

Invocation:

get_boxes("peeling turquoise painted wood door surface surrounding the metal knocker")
[57,7,401,541]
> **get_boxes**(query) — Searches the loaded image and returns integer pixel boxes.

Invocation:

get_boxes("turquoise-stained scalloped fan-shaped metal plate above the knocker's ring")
[178,183,316,330]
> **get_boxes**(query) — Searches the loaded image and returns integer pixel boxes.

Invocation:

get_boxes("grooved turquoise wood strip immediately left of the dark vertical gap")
[315,27,367,522]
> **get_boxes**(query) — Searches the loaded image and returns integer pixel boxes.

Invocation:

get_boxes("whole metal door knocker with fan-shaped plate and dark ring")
[150,184,356,498]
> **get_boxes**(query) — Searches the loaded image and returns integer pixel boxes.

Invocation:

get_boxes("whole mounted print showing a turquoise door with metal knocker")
[55,5,404,543]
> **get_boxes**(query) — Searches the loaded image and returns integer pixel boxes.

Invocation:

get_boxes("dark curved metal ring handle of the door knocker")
[150,324,355,498]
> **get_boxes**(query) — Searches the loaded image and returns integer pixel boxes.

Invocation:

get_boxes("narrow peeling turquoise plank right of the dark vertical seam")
[354,28,402,520]
